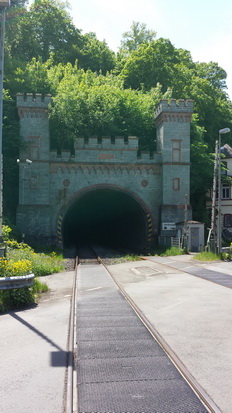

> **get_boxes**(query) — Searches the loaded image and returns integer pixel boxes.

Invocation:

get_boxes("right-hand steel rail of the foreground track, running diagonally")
[98,257,222,413]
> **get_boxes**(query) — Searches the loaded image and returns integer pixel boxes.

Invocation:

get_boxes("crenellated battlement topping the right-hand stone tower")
[154,99,193,119]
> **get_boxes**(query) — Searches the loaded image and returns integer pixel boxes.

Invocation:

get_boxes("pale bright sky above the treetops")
[29,0,232,100]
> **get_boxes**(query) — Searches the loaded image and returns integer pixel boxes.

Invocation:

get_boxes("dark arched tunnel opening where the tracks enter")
[62,189,147,251]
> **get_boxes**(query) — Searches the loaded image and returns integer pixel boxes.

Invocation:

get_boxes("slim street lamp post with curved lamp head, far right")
[217,128,230,254]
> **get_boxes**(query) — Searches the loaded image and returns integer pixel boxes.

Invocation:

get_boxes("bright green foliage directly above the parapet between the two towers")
[51,70,162,148]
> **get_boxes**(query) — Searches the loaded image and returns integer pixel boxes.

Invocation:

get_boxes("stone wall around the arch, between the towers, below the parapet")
[50,165,161,241]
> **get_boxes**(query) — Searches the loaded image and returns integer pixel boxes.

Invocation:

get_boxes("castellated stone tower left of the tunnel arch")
[17,93,51,241]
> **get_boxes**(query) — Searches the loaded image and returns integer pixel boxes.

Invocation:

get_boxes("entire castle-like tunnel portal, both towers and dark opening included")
[16,94,193,249]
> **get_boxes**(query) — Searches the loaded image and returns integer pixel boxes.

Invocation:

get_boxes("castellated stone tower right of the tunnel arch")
[155,99,193,237]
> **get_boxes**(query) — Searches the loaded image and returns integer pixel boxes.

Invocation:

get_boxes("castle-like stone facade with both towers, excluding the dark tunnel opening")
[17,94,193,248]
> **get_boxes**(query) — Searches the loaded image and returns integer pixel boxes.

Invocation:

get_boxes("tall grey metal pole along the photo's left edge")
[0,0,10,243]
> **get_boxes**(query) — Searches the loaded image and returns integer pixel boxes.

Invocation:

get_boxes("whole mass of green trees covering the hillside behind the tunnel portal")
[3,0,232,225]
